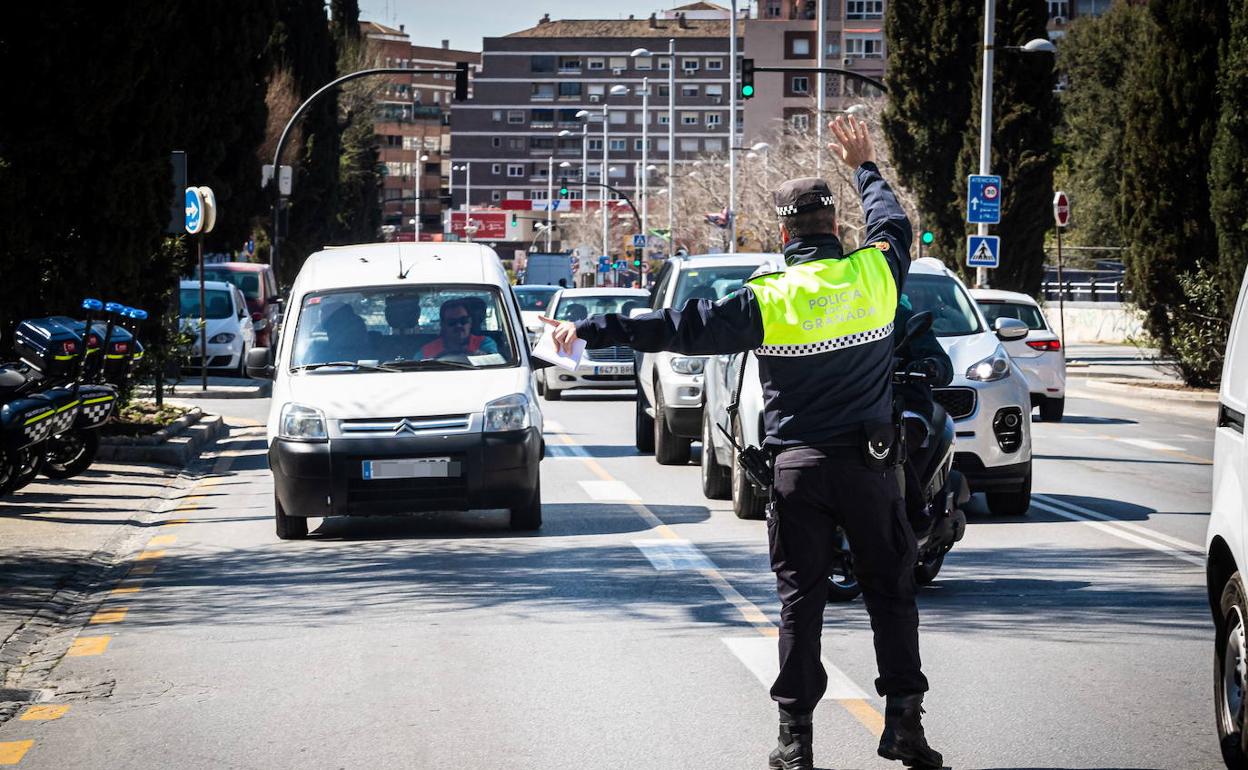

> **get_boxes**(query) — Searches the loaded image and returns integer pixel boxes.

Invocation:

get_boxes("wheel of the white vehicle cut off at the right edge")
[1213,572,1248,770]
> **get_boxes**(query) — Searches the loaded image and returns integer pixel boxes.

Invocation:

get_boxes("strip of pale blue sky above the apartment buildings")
[359,0,673,51]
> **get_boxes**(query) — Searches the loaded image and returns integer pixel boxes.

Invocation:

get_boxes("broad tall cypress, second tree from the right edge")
[1117,0,1226,354]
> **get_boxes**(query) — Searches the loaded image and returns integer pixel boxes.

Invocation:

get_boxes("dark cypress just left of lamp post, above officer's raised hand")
[882,0,982,263]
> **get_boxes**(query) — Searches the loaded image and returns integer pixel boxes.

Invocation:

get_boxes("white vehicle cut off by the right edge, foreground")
[1204,263,1248,770]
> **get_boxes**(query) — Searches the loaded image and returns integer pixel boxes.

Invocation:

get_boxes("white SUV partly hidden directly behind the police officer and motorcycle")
[701,257,1031,518]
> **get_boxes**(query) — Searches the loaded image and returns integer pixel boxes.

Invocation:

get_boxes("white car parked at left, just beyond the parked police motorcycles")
[178,280,256,377]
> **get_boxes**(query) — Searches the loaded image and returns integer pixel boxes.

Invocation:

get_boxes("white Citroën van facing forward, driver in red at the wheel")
[247,243,544,539]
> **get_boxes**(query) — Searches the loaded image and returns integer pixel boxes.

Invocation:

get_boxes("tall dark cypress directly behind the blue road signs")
[957,0,1058,295]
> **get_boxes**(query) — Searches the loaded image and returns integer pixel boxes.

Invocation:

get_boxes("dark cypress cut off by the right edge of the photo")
[1209,0,1248,313]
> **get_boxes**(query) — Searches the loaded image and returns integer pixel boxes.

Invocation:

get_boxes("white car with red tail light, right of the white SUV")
[971,288,1066,422]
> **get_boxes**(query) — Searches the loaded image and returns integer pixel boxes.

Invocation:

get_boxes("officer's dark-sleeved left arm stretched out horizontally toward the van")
[566,288,763,356]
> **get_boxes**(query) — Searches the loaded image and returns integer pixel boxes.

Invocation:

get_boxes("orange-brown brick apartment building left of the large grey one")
[359,21,480,240]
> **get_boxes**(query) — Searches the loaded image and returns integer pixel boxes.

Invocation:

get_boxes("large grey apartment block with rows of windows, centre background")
[453,2,743,248]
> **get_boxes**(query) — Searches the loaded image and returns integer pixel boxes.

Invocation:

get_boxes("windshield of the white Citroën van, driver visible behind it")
[291,286,519,372]
